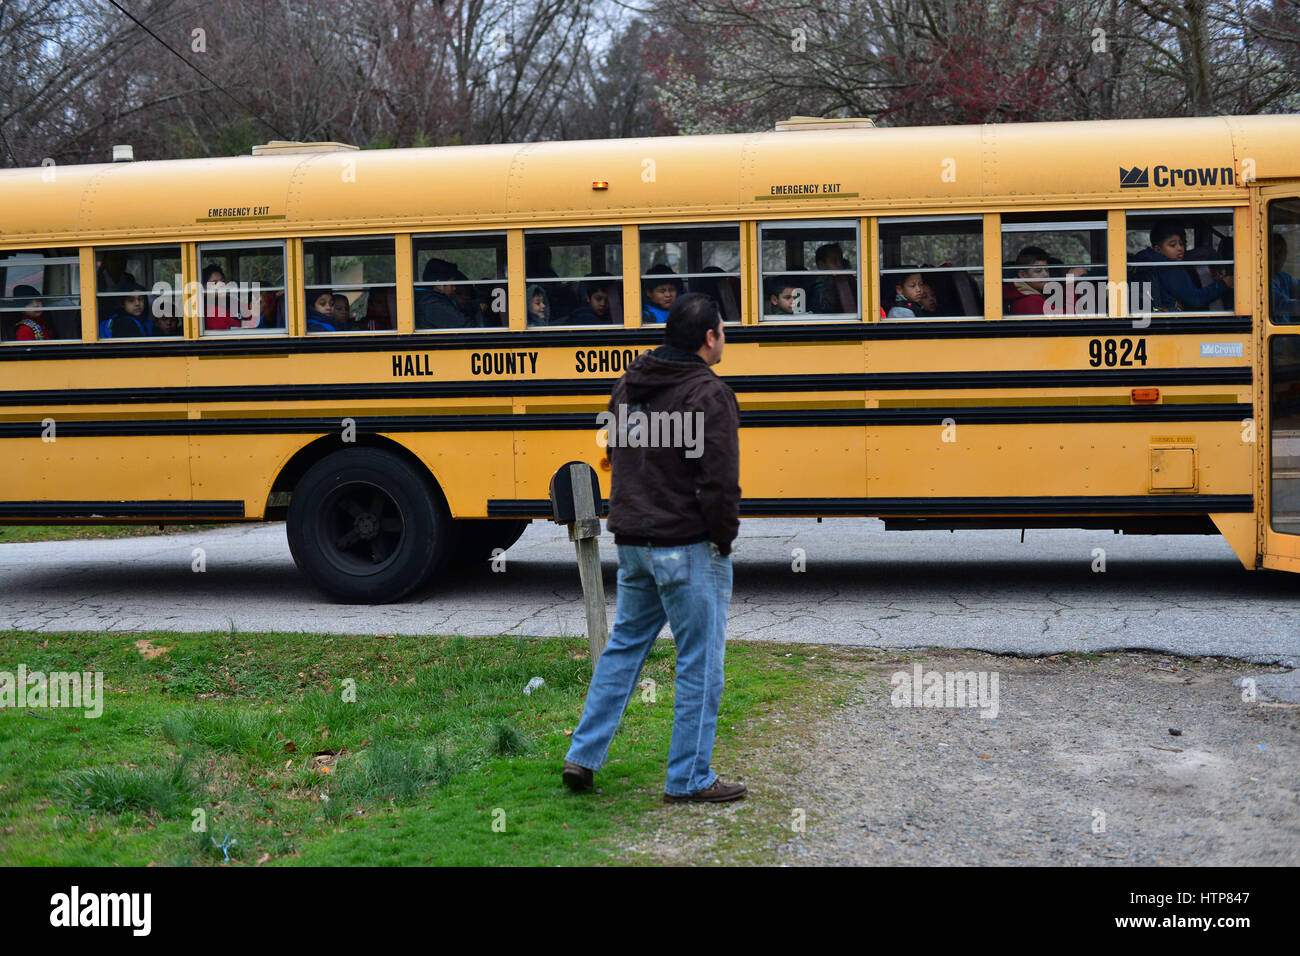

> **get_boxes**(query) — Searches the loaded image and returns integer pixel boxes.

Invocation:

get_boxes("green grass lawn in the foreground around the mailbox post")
[0,632,835,866]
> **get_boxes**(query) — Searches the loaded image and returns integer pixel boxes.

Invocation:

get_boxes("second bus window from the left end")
[95,246,183,342]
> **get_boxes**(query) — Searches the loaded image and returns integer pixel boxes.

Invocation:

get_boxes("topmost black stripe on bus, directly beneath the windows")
[0,313,1253,362]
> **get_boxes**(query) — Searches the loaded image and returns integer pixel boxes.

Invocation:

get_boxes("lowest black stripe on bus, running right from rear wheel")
[488,494,1255,518]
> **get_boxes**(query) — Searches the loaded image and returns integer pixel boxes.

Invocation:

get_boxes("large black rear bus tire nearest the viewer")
[286,447,454,604]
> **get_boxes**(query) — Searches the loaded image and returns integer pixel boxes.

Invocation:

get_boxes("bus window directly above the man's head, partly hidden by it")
[641,222,740,324]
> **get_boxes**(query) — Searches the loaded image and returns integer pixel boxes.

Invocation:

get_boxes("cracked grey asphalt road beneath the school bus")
[0,518,1300,666]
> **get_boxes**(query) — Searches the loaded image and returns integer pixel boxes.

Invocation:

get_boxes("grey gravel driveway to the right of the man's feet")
[632,648,1300,866]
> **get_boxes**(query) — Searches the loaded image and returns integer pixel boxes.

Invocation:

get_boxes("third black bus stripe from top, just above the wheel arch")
[0,402,1253,440]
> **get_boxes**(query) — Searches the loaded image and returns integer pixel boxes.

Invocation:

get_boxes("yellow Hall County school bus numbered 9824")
[0,116,1300,601]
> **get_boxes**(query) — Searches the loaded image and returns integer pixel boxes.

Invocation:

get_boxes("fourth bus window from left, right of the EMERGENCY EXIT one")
[303,235,397,334]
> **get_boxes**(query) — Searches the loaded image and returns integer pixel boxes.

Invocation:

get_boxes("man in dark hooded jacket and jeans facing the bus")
[563,294,745,803]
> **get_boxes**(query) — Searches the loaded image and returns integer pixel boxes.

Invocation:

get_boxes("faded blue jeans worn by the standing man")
[566,541,732,796]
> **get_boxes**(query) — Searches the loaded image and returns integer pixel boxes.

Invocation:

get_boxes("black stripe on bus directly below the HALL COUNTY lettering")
[0,365,1252,406]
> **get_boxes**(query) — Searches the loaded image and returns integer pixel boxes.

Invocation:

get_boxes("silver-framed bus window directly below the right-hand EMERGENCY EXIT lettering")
[758,220,862,321]
